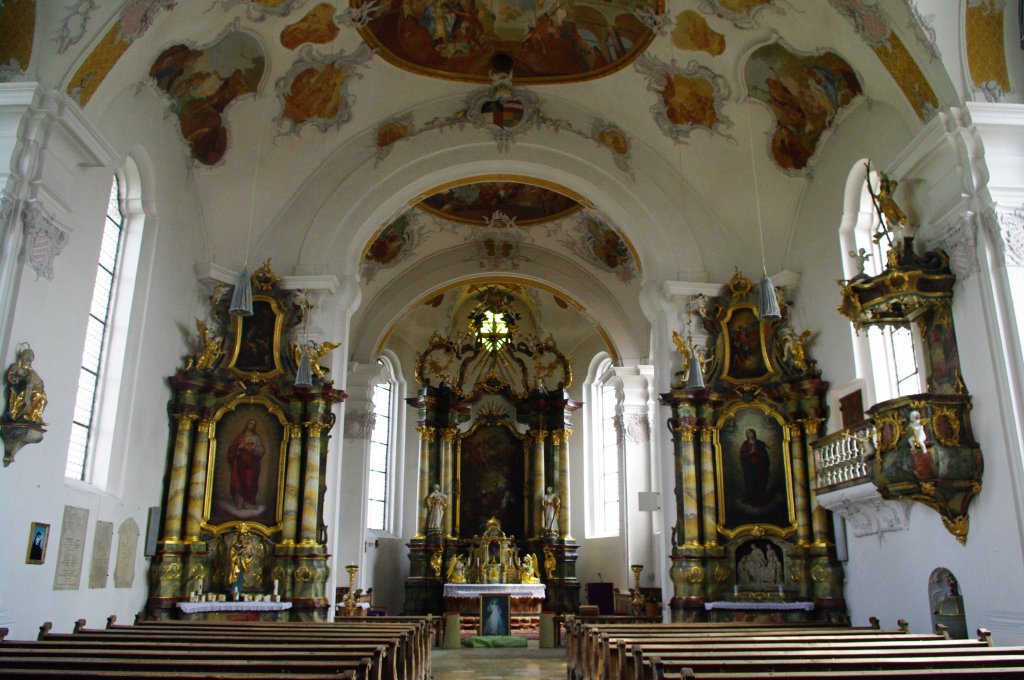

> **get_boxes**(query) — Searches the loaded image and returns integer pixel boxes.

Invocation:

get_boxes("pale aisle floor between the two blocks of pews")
[430,640,565,680]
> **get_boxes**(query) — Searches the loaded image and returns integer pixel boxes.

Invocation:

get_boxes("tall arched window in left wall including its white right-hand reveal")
[65,161,144,486]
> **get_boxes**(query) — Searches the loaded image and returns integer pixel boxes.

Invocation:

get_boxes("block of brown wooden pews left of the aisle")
[0,617,433,680]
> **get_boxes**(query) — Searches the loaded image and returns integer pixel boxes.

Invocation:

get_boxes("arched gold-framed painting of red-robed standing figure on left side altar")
[206,397,288,533]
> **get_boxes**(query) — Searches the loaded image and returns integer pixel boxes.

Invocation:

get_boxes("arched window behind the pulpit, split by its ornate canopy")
[840,160,924,403]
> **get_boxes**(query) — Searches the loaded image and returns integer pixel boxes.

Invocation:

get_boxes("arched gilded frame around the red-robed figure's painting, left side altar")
[200,394,291,536]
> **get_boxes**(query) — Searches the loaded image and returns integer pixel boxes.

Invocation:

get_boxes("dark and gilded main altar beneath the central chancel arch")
[404,286,582,615]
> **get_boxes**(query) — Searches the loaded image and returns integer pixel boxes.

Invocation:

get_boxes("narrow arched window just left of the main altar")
[367,356,399,532]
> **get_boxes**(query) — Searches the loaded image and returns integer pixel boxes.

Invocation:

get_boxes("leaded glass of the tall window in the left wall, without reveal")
[65,176,124,479]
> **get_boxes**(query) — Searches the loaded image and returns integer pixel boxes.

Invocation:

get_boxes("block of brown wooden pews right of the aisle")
[566,619,1024,680]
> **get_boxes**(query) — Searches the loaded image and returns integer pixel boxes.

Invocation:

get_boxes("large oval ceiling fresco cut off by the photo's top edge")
[352,0,665,83]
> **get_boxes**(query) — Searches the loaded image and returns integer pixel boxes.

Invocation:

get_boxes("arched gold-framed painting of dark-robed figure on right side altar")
[715,402,796,538]
